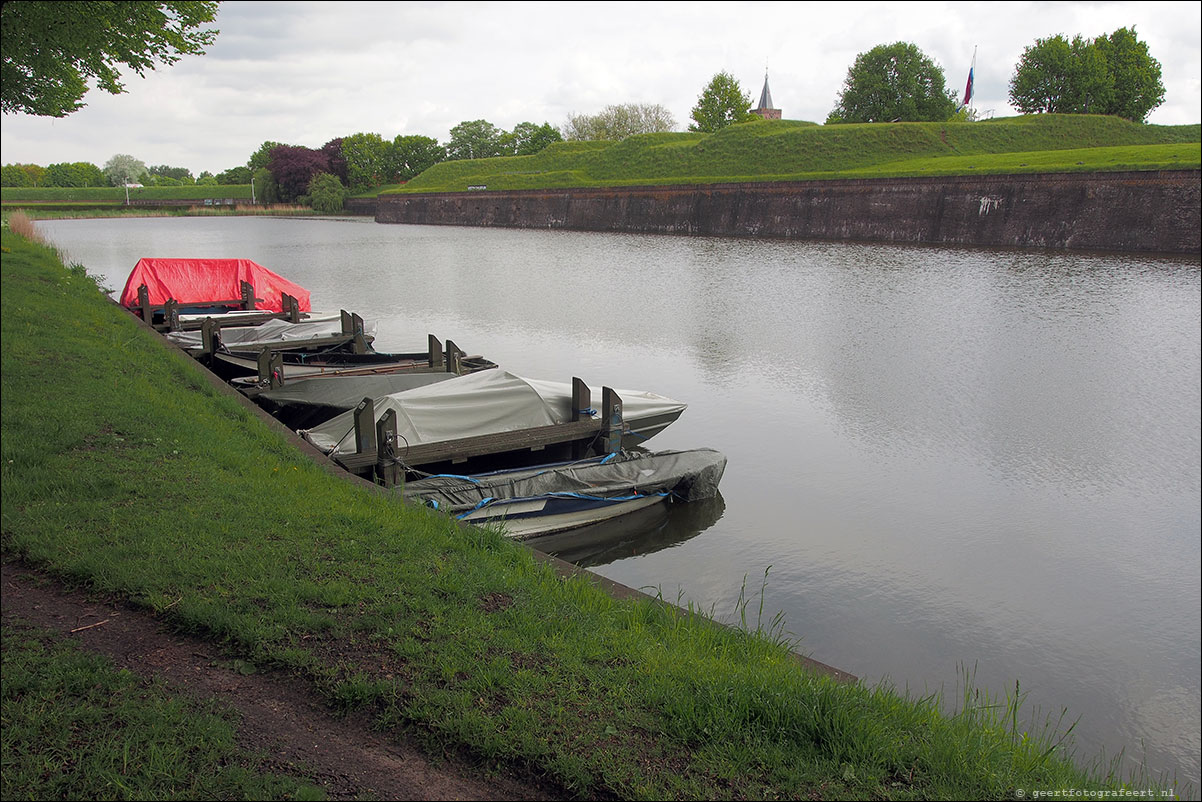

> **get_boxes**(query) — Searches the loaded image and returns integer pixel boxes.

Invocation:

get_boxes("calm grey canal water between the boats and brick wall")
[38,219,1202,794]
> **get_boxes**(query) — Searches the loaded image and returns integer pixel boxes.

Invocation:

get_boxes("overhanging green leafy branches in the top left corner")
[0,0,218,117]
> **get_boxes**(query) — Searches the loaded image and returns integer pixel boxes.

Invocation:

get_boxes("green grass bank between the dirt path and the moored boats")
[0,222,1177,800]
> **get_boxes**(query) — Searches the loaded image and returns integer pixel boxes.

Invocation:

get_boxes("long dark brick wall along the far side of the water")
[376,171,1202,254]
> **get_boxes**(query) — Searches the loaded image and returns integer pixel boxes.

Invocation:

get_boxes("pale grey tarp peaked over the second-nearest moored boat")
[301,370,686,456]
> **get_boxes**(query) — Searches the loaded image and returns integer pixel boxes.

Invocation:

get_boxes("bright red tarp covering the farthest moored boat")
[121,259,313,311]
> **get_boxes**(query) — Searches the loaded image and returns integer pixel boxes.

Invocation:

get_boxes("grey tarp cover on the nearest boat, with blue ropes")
[401,448,726,512]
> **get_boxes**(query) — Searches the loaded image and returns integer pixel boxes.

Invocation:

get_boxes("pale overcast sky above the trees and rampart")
[2,0,1202,174]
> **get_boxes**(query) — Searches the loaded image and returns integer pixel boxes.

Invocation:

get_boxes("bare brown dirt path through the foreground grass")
[2,563,561,800]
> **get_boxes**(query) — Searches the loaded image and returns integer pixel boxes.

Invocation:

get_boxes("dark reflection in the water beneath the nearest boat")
[526,493,726,568]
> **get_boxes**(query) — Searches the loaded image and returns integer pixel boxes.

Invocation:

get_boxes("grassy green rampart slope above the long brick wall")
[381,114,1202,194]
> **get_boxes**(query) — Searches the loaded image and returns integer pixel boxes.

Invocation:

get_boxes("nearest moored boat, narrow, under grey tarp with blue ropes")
[401,448,726,539]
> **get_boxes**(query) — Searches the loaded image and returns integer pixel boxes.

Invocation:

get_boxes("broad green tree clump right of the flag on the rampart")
[1010,28,1165,123]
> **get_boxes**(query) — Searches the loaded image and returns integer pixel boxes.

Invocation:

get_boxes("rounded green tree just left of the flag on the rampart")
[826,42,957,125]
